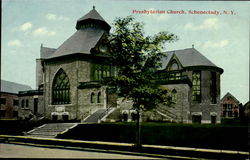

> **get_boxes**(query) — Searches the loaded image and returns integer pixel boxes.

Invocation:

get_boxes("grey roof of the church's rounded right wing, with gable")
[160,48,222,69]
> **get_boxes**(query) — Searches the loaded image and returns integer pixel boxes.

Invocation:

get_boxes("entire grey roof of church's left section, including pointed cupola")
[45,7,110,59]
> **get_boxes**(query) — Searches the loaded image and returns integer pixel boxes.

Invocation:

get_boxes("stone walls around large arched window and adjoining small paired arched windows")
[44,59,110,120]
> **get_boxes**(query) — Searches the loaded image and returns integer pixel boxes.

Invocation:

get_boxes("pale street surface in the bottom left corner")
[0,143,162,159]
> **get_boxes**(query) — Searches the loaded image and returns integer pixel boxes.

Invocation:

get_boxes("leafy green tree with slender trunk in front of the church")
[104,16,177,146]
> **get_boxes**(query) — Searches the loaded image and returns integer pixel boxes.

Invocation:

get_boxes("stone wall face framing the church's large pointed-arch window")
[44,59,80,119]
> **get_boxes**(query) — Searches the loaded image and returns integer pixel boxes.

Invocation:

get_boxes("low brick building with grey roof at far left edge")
[0,80,32,119]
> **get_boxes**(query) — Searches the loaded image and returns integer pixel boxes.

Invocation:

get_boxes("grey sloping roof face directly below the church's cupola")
[48,28,105,58]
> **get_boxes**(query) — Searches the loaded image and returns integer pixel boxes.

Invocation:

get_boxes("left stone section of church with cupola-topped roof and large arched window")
[37,6,114,120]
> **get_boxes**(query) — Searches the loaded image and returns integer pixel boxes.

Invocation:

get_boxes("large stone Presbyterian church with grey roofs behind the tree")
[19,7,223,123]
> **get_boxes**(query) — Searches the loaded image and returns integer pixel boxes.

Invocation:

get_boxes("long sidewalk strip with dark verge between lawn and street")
[0,135,249,159]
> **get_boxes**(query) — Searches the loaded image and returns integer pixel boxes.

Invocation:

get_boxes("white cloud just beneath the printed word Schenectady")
[184,18,221,30]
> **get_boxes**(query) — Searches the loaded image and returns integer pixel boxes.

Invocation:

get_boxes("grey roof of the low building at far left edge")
[1,80,32,94]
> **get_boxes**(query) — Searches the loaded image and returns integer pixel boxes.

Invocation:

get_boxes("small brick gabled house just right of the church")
[220,92,240,118]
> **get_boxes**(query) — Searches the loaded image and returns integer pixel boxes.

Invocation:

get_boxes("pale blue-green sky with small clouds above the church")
[1,0,250,104]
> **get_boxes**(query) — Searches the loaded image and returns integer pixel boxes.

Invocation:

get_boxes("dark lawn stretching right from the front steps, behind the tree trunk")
[58,123,248,151]
